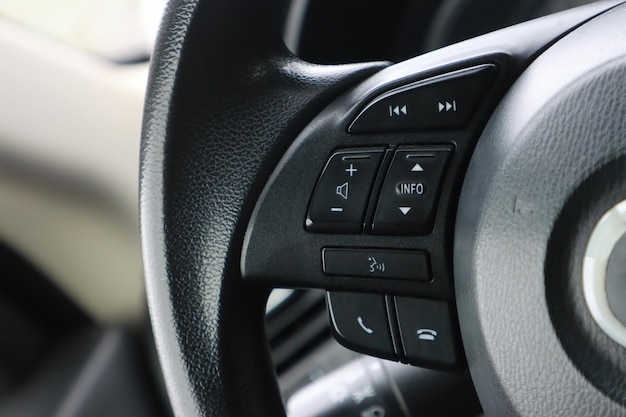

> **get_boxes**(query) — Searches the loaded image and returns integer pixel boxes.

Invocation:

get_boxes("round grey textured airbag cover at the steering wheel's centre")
[454,6,626,416]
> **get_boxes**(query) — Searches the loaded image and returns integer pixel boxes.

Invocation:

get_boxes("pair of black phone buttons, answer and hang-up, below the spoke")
[326,292,463,369]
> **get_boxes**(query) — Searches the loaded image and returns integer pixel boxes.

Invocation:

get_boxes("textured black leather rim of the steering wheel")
[140,0,383,416]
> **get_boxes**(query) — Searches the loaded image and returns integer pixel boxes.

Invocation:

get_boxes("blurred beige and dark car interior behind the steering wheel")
[0,0,604,417]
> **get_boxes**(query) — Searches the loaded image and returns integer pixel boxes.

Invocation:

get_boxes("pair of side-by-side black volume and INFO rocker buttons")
[306,145,452,235]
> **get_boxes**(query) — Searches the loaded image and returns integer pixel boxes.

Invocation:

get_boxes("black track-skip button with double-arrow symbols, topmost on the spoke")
[348,64,497,133]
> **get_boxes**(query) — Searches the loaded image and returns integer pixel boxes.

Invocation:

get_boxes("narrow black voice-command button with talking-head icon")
[322,248,431,281]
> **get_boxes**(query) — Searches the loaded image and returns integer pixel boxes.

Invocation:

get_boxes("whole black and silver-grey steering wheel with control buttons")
[140,0,626,416]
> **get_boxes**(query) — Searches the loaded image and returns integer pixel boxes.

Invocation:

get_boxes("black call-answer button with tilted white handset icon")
[326,292,395,359]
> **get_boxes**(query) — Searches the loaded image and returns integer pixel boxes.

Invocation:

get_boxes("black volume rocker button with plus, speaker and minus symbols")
[306,148,384,233]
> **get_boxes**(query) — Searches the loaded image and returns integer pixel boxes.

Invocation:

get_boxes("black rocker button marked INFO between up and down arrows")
[372,146,452,235]
